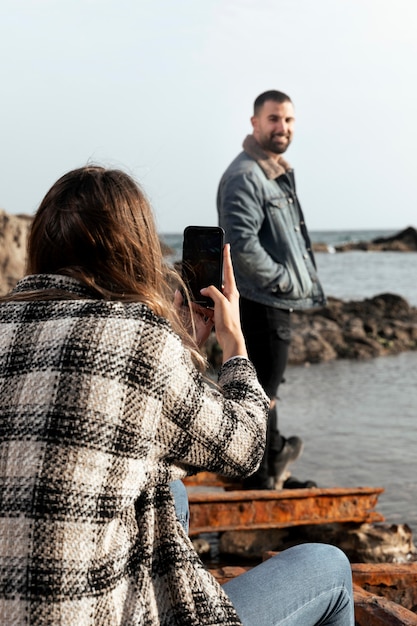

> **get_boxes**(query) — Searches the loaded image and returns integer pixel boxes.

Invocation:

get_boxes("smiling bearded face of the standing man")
[251,100,295,156]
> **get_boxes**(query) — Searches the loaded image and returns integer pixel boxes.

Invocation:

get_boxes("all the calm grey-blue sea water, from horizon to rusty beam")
[161,231,417,541]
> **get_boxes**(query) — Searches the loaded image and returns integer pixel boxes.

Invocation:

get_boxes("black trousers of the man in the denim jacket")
[240,298,291,482]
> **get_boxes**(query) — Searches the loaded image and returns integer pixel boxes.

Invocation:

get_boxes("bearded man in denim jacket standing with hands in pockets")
[217,91,325,489]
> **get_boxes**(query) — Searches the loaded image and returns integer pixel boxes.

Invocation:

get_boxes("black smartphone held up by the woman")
[181,226,224,308]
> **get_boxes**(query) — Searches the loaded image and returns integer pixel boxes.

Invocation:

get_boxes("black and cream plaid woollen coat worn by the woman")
[0,276,268,626]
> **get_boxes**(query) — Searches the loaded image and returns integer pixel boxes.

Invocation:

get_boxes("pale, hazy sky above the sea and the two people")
[0,0,417,234]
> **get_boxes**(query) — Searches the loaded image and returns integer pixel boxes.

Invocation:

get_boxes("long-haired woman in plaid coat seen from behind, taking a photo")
[0,166,353,626]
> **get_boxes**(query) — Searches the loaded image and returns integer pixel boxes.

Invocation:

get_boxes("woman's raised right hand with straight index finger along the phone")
[201,244,248,362]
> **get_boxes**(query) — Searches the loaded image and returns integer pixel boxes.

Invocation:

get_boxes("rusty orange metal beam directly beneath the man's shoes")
[188,487,384,535]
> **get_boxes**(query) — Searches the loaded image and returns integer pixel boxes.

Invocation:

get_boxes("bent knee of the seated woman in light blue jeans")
[223,543,354,626]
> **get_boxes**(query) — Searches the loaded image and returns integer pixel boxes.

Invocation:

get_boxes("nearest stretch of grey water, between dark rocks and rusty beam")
[278,352,417,541]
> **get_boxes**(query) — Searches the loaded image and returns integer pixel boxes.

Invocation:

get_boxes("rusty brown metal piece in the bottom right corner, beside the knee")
[353,585,417,626]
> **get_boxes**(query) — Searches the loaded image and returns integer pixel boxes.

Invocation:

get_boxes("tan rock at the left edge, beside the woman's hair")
[0,209,32,295]
